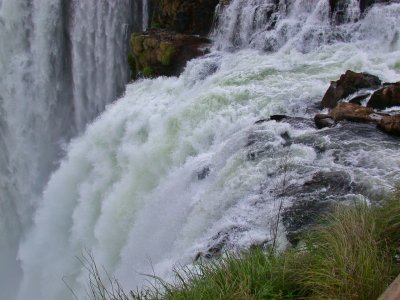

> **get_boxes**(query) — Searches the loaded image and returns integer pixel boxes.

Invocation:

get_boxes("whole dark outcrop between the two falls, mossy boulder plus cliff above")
[128,0,219,79]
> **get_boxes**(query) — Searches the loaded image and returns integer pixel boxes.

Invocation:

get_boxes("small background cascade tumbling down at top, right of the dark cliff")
[213,0,372,52]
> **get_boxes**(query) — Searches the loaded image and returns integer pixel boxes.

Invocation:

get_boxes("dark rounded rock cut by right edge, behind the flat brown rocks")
[367,82,400,109]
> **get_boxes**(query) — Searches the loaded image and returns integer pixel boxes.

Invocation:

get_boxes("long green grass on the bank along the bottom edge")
[85,192,400,300]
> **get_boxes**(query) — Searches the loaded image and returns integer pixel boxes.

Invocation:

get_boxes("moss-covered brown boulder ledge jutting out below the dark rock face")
[131,30,210,77]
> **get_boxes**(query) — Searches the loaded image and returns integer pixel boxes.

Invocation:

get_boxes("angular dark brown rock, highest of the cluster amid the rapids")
[320,70,381,108]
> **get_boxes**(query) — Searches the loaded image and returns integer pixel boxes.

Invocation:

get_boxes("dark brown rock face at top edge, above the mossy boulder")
[150,0,219,35]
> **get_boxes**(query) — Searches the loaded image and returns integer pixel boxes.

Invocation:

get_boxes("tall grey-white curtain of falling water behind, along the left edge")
[0,0,146,300]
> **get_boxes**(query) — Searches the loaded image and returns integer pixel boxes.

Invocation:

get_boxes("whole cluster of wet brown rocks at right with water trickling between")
[314,70,400,135]
